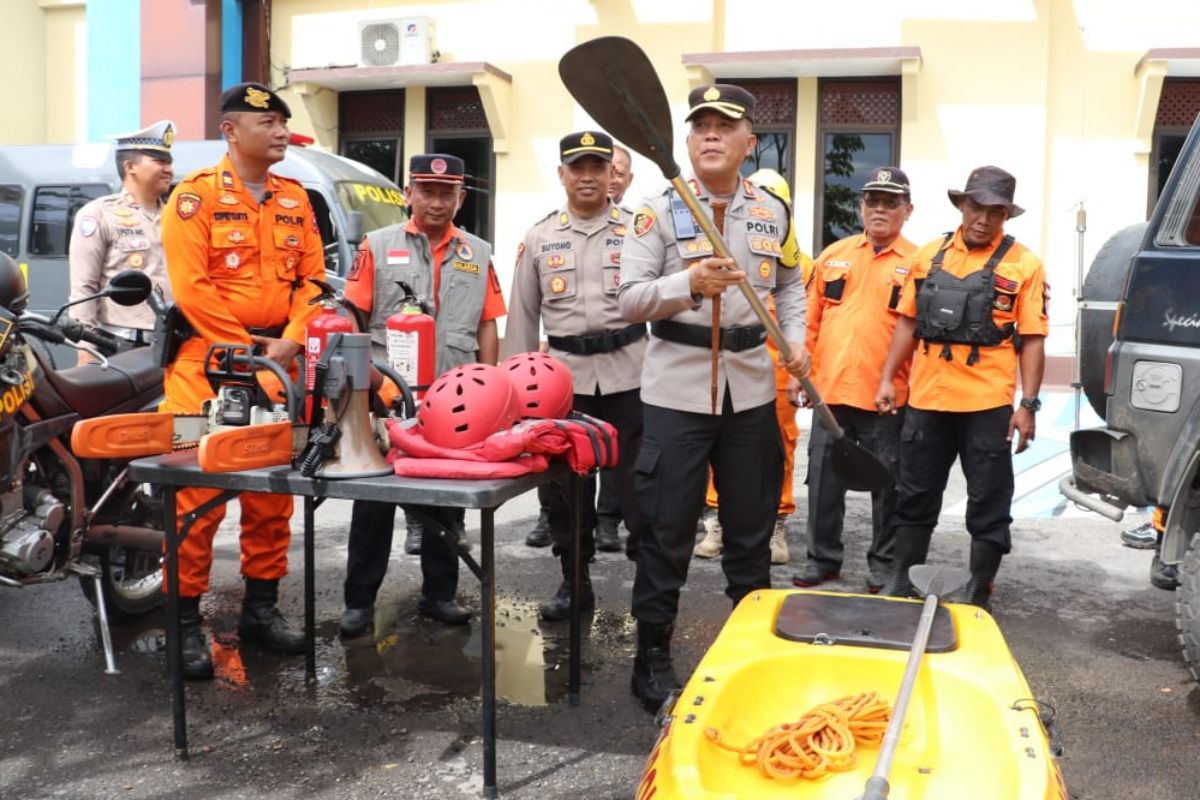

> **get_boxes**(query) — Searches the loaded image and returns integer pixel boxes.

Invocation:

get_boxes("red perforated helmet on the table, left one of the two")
[416,363,520,449]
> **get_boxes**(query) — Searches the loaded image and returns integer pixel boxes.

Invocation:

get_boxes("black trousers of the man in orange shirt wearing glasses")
[806,405,905,572]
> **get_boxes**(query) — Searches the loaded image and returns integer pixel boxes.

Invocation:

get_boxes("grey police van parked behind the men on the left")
[0,140,407,326]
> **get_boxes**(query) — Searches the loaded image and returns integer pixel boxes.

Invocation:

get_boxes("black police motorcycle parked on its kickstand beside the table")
[0,270,163,672]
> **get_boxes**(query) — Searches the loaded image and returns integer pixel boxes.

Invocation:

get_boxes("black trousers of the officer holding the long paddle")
[632,393,784,625]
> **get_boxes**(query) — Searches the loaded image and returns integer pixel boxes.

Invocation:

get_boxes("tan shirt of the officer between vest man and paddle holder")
[500,203,646,395]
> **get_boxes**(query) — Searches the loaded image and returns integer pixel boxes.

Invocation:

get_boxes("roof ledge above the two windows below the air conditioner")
[288,61,512,152]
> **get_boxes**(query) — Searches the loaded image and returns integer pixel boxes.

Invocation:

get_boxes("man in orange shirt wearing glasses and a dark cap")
[792,167,917,594]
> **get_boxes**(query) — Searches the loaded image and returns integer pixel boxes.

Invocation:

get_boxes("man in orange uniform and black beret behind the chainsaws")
[162,83,325,679]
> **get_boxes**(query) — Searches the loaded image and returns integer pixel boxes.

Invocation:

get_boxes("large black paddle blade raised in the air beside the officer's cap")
[558,36,679,180]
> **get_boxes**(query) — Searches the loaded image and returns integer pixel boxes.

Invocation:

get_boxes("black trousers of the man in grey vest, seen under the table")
[342,500,466,608]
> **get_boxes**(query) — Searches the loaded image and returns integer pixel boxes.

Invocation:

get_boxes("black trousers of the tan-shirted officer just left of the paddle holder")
[544,389,642,564]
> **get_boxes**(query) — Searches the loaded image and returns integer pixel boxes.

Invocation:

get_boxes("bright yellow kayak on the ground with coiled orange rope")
[636,590,1068,800]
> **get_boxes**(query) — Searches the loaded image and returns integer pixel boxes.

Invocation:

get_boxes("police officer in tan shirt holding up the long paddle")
[618,84,809,710]
